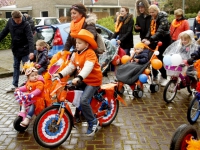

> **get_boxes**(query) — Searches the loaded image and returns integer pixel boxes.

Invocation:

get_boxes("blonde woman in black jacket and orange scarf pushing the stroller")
[142,5,171,86]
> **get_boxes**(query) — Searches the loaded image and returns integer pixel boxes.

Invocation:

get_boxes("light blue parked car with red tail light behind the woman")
[34,23,113,58]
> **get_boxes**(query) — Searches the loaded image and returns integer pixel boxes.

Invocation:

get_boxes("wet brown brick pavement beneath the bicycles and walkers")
[0,73,198,150]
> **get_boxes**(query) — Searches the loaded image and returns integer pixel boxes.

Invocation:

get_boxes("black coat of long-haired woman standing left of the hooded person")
[112,14,134,49]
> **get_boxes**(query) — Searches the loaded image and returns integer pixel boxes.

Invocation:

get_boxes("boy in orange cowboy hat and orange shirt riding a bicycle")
[53,29,102,136]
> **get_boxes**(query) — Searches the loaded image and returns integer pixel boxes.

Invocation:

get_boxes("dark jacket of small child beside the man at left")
[34,49,50,68]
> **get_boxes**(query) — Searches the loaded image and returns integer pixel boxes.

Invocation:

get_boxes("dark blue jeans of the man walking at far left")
[12,55,29,87]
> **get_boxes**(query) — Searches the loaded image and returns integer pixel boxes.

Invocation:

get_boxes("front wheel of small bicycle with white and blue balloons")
[163,80,177,103]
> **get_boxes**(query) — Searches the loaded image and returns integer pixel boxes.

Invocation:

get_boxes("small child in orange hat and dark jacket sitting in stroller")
[131,42,149,64]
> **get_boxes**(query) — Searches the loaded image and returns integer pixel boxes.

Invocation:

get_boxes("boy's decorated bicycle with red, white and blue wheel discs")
[33,79,126,148]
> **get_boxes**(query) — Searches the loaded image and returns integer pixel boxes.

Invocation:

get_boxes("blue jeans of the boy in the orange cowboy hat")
[80,85,99,122]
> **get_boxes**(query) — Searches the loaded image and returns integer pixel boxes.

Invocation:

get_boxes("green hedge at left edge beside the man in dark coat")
[0,18,11,50]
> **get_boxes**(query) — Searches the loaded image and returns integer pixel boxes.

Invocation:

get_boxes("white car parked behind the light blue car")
[33,17,60,26]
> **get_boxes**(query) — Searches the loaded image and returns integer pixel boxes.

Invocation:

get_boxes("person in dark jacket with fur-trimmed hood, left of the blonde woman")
[134,0,151,40]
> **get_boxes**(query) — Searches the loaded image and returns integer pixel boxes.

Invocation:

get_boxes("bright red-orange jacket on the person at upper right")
[169,19,190,41]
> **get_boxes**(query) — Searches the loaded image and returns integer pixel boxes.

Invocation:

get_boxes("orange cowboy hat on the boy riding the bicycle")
[70,29,97,49]
